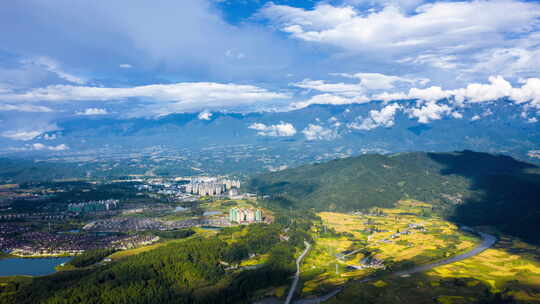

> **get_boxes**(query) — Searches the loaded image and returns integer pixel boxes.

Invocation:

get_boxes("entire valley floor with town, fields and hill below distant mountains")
[0,151,540,304]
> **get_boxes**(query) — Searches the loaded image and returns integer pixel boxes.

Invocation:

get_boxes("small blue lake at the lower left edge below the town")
[0,257,71,277]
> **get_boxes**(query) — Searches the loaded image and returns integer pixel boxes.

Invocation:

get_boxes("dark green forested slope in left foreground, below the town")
[0,224,305,304]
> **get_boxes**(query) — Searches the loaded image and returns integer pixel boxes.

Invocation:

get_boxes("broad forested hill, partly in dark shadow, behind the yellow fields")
[248,151,540,242]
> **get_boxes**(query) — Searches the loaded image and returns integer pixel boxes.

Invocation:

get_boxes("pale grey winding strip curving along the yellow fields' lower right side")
[296,227,497,304]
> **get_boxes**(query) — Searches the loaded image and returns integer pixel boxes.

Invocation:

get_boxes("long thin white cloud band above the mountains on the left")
[0,82,289,111]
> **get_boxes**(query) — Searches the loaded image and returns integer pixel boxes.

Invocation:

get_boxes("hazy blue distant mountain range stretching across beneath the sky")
[0,101,540,172]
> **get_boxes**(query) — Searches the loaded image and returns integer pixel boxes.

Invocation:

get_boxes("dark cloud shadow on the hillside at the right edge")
[428,151,540,243]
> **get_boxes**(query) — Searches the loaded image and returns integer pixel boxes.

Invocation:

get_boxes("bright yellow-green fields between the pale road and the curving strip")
[302,201,484,294]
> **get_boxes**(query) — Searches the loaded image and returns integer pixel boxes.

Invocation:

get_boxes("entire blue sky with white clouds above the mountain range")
[0,0,540,142]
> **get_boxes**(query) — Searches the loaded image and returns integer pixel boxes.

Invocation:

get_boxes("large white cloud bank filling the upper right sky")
[259,0,540,82]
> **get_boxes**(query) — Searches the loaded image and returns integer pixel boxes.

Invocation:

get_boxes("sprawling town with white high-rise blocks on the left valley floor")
[0,176,266,256]
